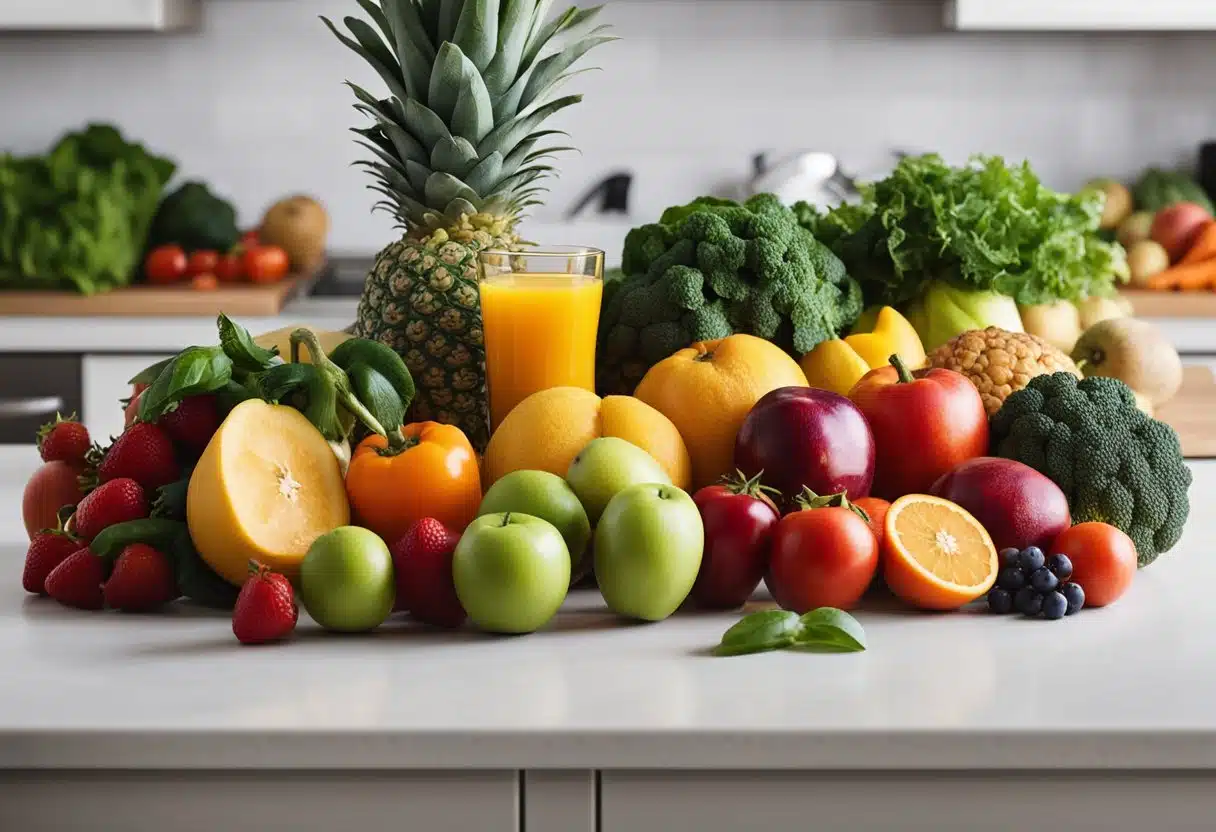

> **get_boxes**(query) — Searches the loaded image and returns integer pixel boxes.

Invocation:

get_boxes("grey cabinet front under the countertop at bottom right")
[599,771,1216,832]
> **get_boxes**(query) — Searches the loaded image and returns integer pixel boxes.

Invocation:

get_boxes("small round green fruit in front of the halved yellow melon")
[299,525,396,633]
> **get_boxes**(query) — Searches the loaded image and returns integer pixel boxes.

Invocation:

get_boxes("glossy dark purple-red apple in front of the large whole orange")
[734,387,874,501]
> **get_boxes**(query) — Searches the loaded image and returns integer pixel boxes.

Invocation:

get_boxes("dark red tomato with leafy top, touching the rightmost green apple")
[692,479,779,609]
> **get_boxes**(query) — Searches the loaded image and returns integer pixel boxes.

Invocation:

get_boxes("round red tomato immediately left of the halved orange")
[765,506,878,614]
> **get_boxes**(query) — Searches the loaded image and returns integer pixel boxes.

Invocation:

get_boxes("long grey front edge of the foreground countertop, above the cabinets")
[0,729,1216,771]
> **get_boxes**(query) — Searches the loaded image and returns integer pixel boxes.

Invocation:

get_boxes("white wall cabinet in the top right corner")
[945,0,1216,32]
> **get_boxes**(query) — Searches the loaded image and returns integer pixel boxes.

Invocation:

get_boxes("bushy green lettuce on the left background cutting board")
[0,124,175,294]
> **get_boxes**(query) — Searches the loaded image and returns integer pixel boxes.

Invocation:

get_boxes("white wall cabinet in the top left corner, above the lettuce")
[0,0,202,32]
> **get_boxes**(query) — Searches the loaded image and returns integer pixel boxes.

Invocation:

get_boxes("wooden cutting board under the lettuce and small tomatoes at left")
[0,275,313,317]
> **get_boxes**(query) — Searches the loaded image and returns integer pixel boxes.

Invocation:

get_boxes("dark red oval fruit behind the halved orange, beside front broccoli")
[931,456,1073,551]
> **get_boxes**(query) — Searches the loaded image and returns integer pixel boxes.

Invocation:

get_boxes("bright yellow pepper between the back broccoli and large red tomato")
[799,307,925,395]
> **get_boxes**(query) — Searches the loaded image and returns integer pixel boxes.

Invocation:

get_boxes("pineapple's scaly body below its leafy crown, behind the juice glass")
[353,229,518,452]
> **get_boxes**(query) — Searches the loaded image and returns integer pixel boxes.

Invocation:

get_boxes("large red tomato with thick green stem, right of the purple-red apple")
[849,364,989,500]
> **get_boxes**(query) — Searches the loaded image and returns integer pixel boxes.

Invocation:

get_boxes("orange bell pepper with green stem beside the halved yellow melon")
[347,422,482,546]
